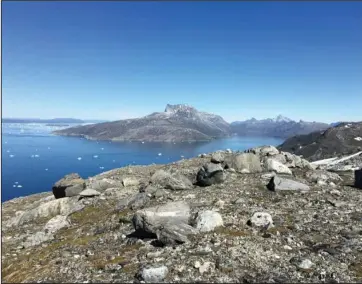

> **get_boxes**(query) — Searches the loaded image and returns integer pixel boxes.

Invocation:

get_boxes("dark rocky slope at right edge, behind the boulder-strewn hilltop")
[278,122,362,161]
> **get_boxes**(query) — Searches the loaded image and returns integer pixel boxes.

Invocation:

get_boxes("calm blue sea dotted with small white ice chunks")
[1,123,282,202]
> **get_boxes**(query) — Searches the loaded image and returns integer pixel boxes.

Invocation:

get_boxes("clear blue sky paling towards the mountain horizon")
[2,1,362,122]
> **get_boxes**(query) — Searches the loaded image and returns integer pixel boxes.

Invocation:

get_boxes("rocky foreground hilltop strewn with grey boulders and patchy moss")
[1,146,362,283]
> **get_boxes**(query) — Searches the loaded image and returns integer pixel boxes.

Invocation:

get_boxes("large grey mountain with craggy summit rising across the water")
[54,104,230,142]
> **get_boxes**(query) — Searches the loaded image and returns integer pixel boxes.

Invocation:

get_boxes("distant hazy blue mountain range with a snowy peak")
[231,115,329,138]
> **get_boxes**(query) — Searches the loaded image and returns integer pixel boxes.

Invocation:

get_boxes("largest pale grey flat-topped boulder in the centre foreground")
[132,201,191,234]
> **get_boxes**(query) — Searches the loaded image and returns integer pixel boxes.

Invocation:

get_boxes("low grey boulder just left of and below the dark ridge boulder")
[151,170,193,190]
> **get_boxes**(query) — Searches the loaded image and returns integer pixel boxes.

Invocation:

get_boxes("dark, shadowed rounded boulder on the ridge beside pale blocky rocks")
[196,163,225,186]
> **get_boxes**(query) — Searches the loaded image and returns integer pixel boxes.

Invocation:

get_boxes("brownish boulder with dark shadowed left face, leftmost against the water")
[52,173,86,198]
